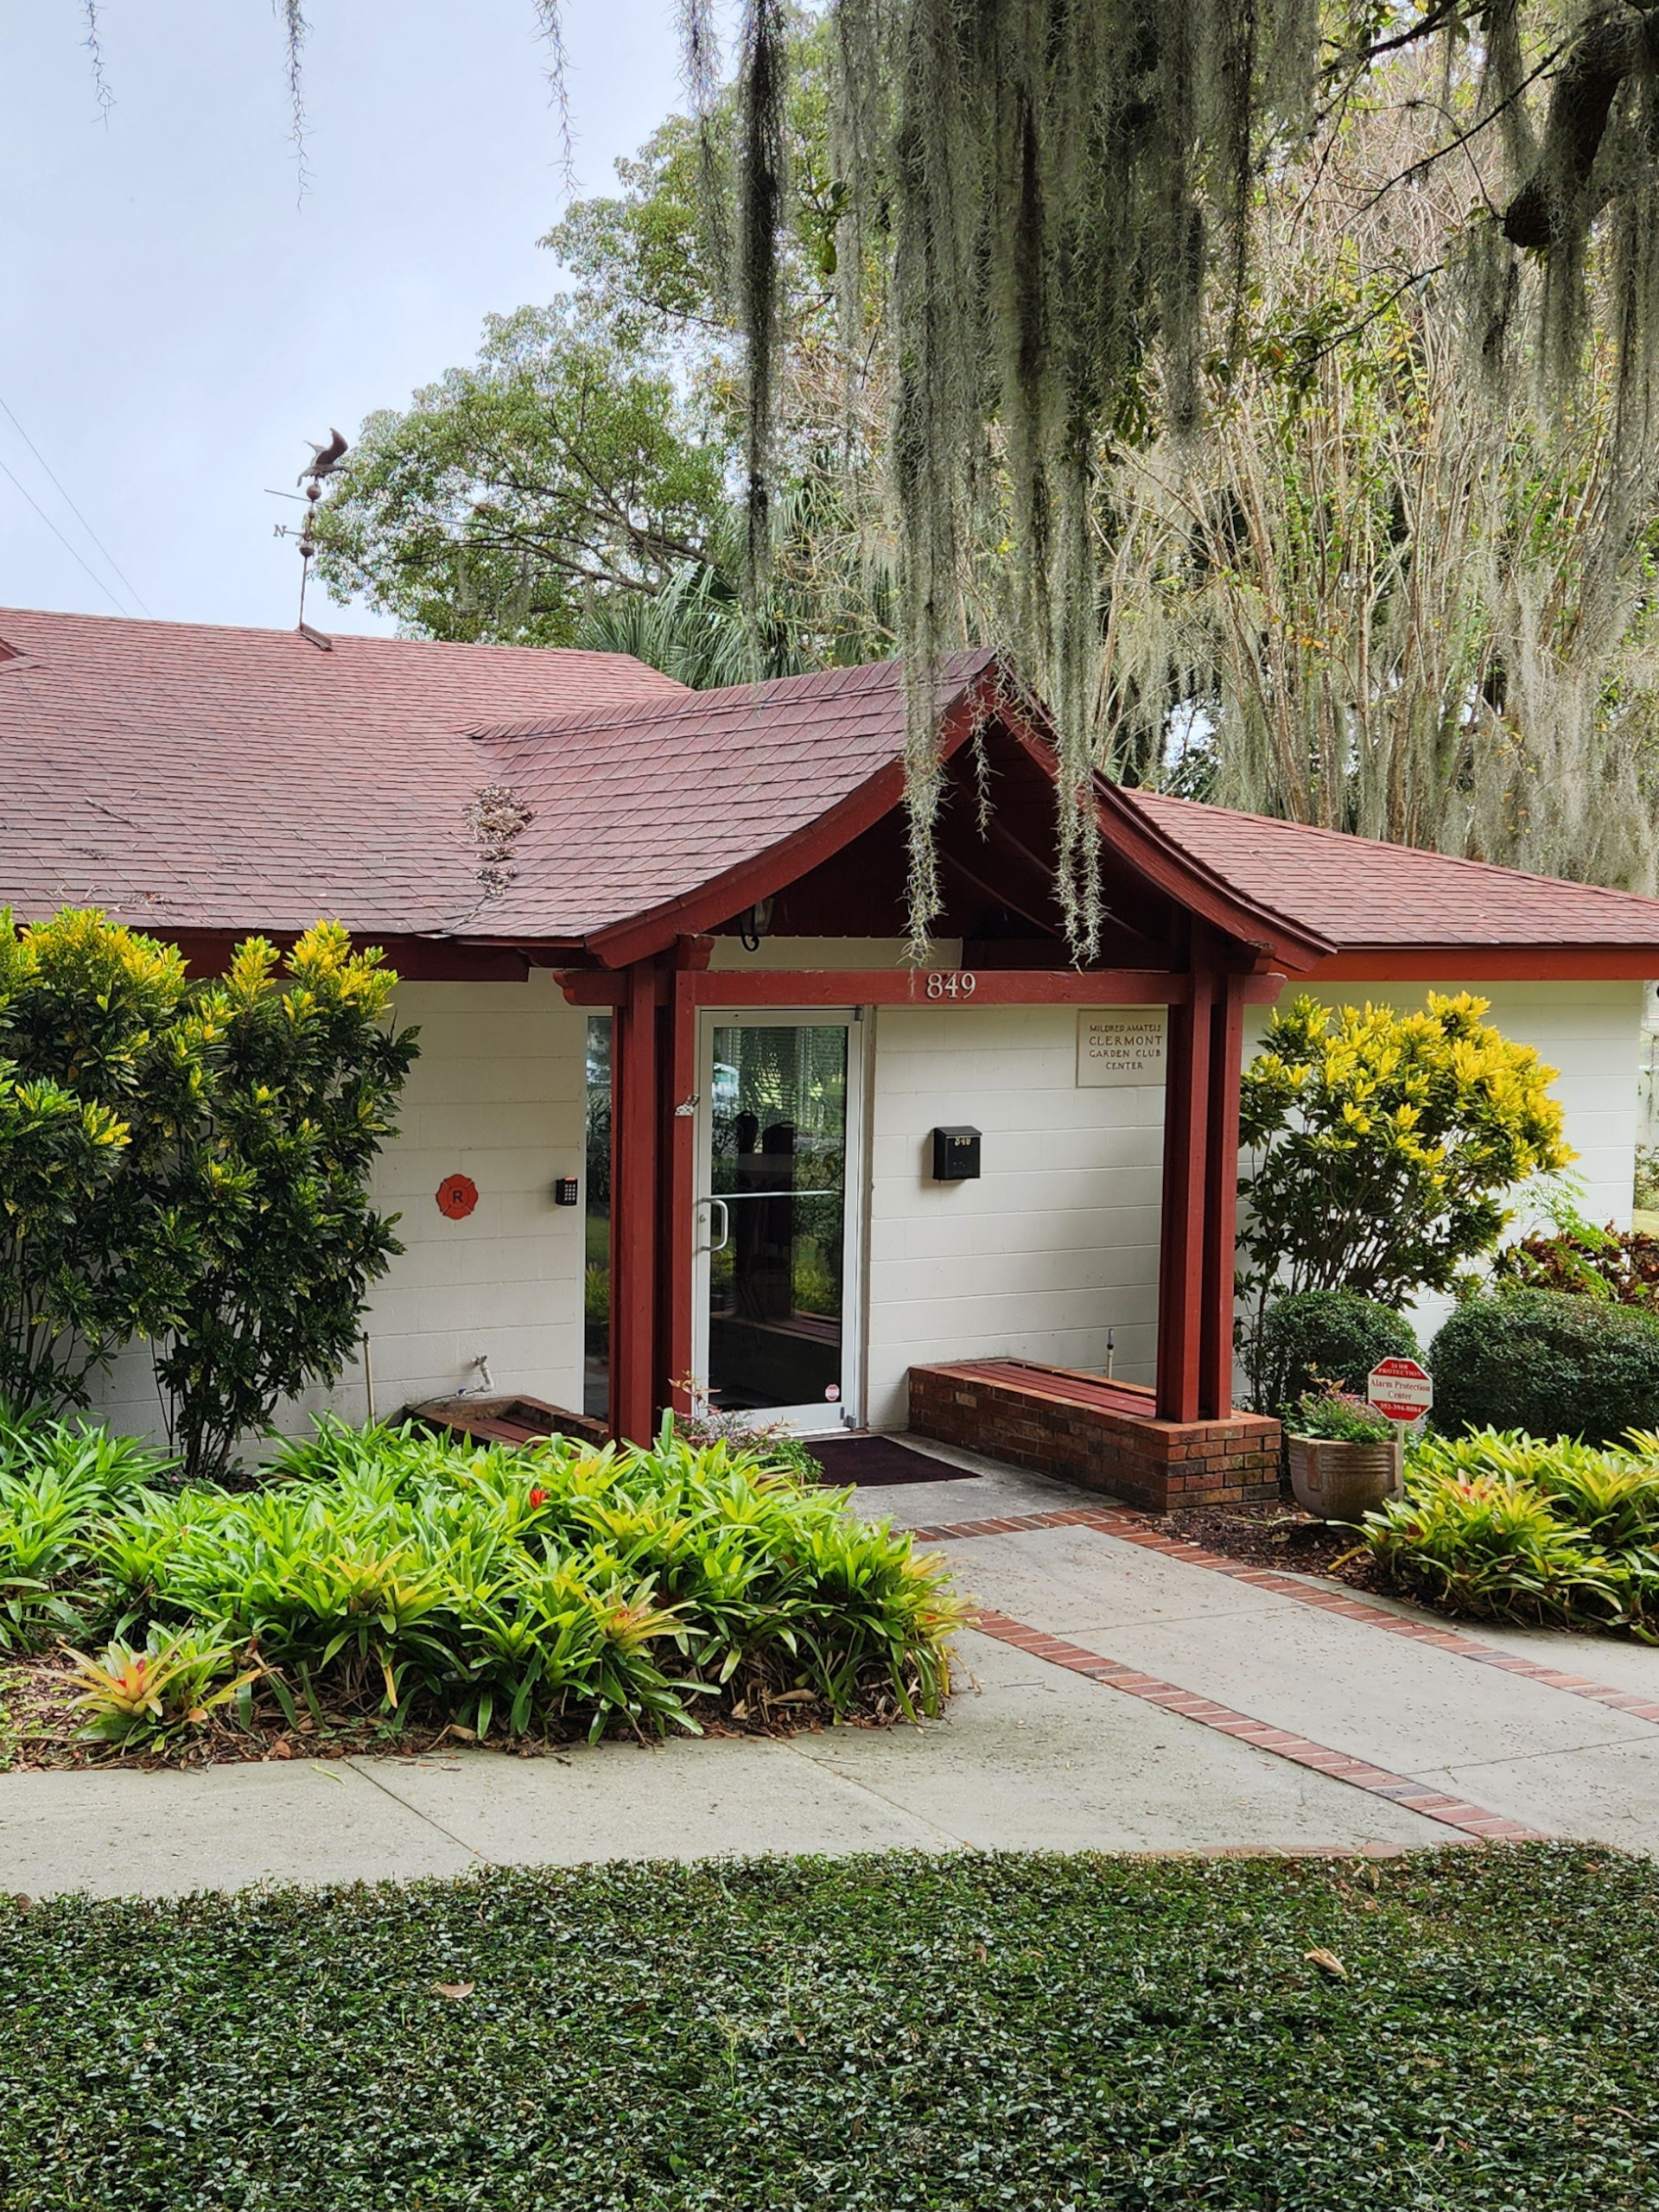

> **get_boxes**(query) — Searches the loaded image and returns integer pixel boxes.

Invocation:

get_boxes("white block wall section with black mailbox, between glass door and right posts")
[865,1007,1164,1429]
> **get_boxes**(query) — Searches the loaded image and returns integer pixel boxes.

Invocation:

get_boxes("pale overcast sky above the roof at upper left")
[0,0,703,631]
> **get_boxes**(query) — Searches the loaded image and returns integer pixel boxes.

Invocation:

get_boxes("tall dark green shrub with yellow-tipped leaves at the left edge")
[0,909,416,1476]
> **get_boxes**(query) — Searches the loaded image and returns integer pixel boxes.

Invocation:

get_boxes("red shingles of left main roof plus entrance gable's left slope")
[0,611,988,938]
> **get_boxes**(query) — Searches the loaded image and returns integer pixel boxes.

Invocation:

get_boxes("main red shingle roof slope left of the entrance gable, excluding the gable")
[0,608,686,936]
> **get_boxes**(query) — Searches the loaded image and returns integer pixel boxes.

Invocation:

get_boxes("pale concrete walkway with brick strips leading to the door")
[0,1446,1659,1896]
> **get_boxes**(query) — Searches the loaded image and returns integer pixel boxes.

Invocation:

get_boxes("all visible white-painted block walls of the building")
[81,964,1643,1435]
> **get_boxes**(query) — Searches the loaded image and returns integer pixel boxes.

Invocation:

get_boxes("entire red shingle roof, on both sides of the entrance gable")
[0,611,1659,973]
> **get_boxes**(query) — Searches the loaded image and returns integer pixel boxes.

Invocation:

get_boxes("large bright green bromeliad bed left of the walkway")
[0,1422,964,1754]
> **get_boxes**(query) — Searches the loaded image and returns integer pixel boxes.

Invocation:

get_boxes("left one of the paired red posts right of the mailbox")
[1157,971,1214,1421]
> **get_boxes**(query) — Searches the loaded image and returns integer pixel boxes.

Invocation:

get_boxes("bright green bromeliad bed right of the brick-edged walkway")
[1365,1429,1659,1643]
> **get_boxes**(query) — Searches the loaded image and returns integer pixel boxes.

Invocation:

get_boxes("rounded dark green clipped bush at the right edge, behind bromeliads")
[1429,1289,1659,1445]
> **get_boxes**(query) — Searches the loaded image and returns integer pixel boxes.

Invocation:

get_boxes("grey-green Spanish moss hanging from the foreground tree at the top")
[708,0,1659,956]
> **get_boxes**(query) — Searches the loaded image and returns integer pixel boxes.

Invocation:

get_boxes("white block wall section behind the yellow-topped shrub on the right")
[1243,982,1646,1344]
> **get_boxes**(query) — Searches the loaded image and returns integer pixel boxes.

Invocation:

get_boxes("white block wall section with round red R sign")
[95,971,586,1440]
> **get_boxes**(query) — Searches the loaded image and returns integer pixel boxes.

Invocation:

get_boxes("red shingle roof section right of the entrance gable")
[1123,791,1659,951]
